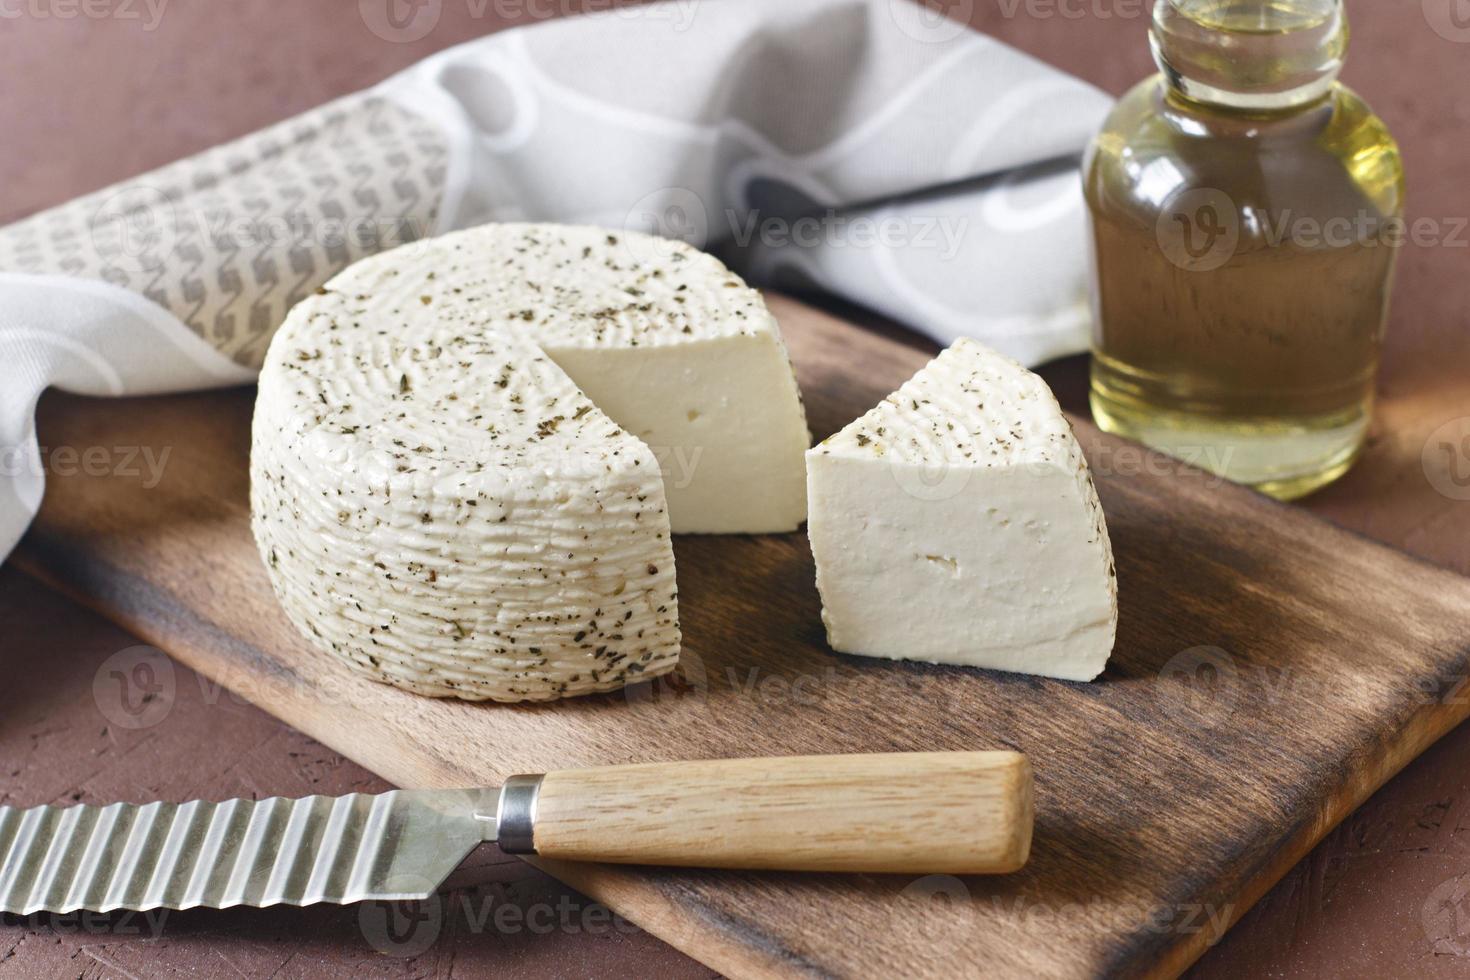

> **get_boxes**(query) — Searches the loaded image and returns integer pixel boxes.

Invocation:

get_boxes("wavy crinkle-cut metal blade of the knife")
[0,789,498,915]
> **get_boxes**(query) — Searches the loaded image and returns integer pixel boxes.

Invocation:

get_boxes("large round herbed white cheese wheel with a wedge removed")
[251,225,809,701]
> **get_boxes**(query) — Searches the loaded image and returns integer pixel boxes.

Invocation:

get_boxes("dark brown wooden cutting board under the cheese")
[18,298,1470,977]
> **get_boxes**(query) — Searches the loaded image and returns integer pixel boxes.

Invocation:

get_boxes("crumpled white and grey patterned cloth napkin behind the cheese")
[0,0,1110,557]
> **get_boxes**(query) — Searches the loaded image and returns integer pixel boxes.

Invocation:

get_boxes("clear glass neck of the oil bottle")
[1150,0,1348,112]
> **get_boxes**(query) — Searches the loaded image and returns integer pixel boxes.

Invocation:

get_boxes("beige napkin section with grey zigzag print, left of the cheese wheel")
[0,94,447,367]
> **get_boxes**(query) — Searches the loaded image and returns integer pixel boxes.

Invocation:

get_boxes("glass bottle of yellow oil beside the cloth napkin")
[1083,0,1404,500]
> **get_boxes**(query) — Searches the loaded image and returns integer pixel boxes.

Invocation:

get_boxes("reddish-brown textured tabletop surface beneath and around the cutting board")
[0,0,1470,977]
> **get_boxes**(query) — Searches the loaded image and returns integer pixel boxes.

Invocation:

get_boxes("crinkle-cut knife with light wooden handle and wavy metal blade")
[0,752,1032,915]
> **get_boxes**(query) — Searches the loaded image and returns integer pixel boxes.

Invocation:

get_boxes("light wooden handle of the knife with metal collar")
[500,752,1032,874]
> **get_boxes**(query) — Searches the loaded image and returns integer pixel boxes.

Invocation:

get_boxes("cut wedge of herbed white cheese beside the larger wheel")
[807,339,1117,680]
